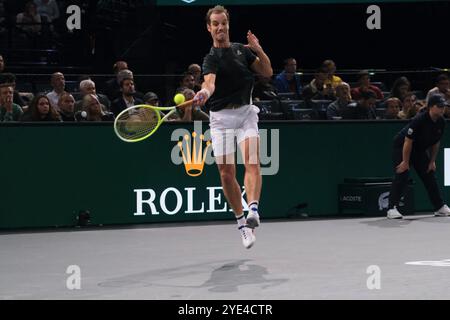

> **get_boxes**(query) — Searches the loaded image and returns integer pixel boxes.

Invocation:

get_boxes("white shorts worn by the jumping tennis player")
[209,104,259,157]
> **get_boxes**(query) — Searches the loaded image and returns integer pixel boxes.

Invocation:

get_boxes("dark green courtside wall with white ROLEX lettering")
[0,121,450,229]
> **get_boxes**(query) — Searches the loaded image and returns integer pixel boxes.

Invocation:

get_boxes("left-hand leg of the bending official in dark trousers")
[387,147,409,219]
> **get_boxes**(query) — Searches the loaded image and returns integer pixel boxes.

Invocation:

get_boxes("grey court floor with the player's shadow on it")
[0,215,450,300]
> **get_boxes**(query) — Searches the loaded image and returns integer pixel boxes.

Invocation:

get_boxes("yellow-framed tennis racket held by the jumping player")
[114,100,194,142]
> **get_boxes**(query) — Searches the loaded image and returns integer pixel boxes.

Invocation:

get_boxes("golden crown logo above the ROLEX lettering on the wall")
[178,131,211,177]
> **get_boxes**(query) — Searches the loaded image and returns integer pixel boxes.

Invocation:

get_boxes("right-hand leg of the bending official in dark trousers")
[414,152,450,216]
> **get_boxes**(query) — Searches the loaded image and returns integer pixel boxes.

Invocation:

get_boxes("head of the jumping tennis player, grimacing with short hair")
[206,5,230,46]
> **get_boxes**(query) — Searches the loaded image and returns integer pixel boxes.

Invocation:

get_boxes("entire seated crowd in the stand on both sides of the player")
[0,55,450,122]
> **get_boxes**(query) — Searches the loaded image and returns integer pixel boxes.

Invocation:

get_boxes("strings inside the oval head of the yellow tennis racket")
[117,108,160,139]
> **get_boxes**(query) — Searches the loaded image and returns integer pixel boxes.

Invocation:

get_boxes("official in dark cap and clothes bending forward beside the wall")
[387,94,450,219]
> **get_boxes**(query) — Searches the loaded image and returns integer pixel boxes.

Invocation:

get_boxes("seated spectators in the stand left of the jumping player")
[0,55,213,122]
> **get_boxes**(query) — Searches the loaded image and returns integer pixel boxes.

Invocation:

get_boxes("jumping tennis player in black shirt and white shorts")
[194,5,273,249]
